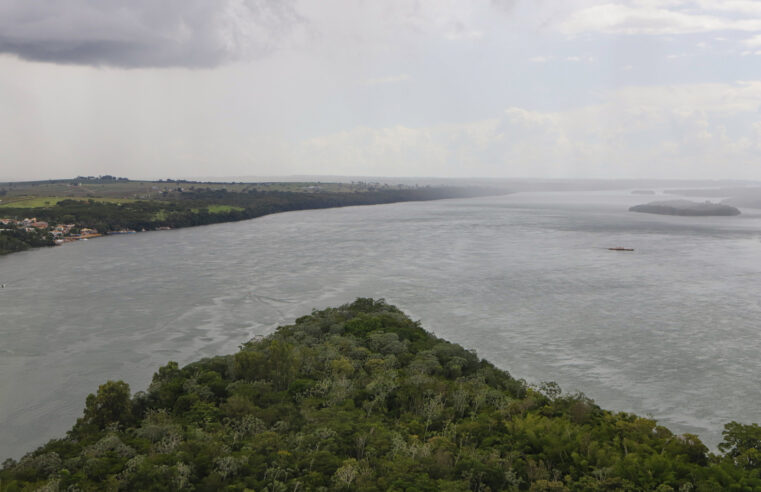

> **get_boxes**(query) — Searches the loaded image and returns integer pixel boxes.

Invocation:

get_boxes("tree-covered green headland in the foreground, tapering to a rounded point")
[0,299,761,492]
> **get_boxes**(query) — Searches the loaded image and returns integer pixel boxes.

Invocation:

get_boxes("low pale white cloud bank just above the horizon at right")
[294,82,761,178]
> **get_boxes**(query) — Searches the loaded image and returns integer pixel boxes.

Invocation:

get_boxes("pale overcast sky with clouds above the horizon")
[0,0,761,180]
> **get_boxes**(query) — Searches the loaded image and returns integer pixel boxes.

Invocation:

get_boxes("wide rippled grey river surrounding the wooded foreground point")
[0,191,761,461]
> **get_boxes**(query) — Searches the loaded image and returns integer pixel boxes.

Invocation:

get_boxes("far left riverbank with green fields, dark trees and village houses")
[0,176,507,254]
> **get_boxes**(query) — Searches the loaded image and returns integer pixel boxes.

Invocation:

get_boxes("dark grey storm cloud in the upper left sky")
[0,0,300,67]
